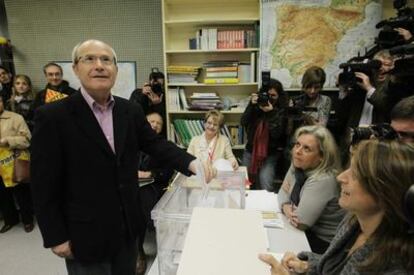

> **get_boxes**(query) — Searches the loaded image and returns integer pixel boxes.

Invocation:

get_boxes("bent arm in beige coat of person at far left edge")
[0,114,31,149]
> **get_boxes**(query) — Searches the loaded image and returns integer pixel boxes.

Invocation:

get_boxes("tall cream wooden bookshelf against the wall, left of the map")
[162,0,260,150]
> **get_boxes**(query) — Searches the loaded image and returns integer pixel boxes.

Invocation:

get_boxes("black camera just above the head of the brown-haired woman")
[350,123,398,145]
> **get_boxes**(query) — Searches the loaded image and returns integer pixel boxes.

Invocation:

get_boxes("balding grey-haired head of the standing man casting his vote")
[73,41,118,96]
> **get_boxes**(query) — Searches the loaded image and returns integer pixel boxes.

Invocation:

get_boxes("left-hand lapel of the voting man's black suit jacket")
[69,93,116,156]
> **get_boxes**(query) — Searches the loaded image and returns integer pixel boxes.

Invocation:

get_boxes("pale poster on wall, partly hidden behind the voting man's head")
[56,61,137,99]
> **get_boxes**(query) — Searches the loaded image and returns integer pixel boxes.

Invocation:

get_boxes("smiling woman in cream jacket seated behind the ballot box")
[187,110,239,170]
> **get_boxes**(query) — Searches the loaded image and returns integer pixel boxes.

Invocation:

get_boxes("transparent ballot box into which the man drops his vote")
[151,171,246,275]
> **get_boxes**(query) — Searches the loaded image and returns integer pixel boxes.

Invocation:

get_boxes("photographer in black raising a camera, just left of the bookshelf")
[129,68,166,136]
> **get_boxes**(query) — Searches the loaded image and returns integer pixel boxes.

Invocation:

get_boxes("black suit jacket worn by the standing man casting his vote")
[31,92,193,261]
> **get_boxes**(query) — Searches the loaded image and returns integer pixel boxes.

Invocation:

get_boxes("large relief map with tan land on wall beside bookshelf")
[260,0,382,88]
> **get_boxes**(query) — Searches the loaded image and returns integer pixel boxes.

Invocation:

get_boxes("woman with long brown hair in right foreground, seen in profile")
[259,139,414,275]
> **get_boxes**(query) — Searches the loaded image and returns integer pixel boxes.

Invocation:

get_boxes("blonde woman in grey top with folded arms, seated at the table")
[278,125,344,253]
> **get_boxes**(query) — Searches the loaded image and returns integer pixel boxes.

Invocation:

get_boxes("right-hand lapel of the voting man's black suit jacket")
[112,97,128,158]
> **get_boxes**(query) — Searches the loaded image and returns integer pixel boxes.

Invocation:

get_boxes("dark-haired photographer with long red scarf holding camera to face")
[241,78,288,191]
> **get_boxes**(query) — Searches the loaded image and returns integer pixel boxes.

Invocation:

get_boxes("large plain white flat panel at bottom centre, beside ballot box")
[177,208,269,275]
